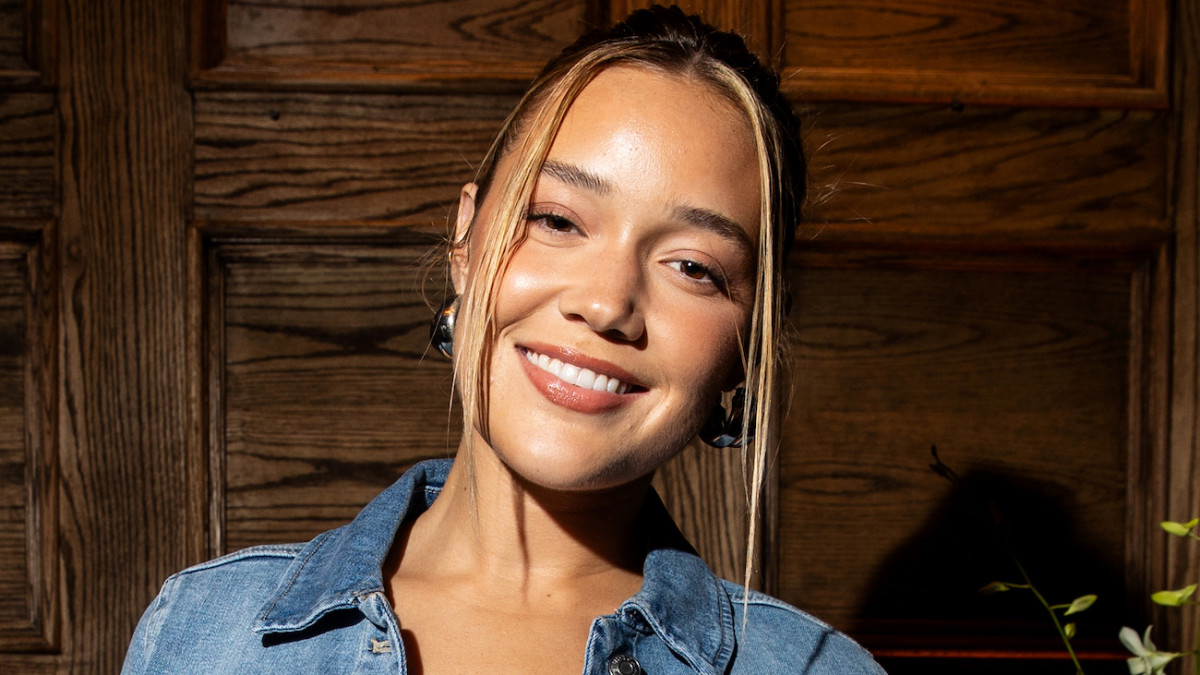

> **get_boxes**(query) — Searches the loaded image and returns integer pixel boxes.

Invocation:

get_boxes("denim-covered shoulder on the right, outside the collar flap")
[721,580,883,675]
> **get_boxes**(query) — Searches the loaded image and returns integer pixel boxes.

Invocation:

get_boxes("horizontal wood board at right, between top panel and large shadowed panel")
[798,106,1170,247]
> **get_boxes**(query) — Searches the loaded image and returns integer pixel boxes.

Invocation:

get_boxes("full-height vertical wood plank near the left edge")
[53,0,194,673]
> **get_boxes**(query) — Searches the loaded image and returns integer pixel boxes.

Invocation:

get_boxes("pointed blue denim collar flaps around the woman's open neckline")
[253,460,734,673]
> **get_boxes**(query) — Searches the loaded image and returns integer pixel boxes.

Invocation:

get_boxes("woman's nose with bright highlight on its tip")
[558,255,646,342]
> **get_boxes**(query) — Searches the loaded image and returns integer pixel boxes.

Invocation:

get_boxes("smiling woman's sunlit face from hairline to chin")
[460,66,760,490]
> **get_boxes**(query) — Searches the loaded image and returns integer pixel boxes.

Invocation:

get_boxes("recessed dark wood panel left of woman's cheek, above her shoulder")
[209,238,461,552]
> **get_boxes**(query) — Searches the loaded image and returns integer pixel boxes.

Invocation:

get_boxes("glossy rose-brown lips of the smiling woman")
[515,344,646,413]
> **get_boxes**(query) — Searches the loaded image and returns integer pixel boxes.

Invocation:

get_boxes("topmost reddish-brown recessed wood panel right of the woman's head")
[782,0,1168,107]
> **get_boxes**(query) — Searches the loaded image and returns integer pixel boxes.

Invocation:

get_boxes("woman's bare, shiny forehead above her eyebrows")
[544,66,760,237]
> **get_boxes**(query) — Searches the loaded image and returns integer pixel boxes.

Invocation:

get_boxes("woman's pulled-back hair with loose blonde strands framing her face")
[454,7,804,587]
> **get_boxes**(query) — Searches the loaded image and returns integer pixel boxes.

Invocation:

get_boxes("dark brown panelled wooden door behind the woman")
[0,0,1200,673]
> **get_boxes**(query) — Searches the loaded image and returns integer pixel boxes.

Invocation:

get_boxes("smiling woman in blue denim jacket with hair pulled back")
[126,8,882,675]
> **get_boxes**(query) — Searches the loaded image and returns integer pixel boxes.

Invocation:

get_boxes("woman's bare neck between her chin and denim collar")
[391,440,649,602]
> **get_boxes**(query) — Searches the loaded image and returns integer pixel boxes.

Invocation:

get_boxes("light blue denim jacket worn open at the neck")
[122,460,883,675]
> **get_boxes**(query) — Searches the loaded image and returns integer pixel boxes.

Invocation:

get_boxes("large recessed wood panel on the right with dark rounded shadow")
[776,261,1150,652]
